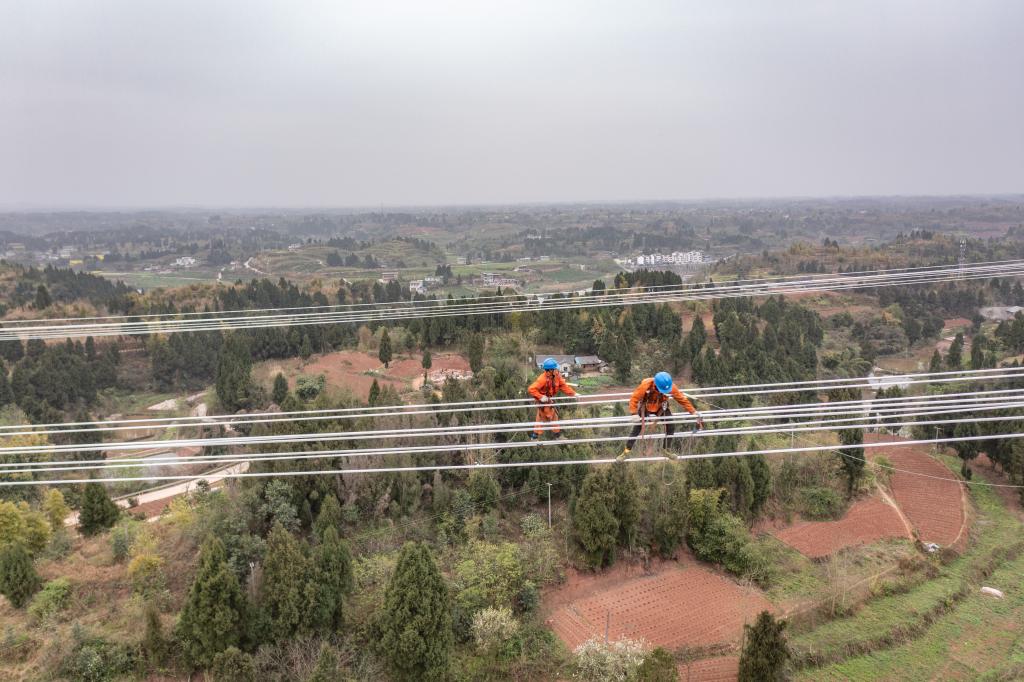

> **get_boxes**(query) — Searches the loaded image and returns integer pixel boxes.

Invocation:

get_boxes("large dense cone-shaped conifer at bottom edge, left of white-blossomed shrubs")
[377,543,454,681]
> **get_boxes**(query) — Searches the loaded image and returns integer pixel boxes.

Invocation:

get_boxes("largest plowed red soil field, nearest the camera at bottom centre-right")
[545,562,771,649]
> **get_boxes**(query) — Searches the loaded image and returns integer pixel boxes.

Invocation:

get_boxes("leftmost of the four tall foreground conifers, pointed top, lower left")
[176,536,247,666]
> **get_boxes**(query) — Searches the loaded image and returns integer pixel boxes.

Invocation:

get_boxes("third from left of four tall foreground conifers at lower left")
[303,527,353,634]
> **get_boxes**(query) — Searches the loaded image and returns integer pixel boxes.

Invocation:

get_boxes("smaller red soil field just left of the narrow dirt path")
[772,497,909,559]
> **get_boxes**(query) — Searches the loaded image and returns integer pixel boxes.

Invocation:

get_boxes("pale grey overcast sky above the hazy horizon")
[0,0,1024,208]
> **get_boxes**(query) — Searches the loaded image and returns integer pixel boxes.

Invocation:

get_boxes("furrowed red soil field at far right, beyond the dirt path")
[864,433,967,547]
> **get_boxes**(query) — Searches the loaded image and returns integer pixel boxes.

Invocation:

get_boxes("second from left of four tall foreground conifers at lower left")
[259,523,306,641]
